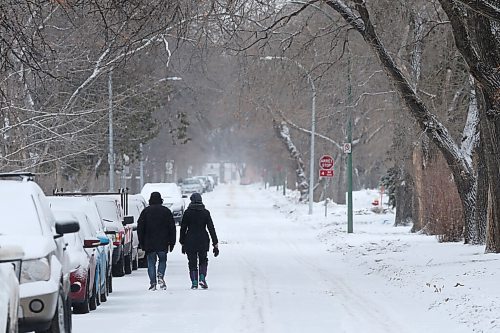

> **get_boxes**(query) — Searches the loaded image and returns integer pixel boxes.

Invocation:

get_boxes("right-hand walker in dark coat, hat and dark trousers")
[179,193,219,289]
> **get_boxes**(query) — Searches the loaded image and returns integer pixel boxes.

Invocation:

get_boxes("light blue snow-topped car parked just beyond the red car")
[47,193,116,296]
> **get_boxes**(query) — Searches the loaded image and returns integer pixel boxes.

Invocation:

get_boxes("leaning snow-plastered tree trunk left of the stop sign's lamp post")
[274,121,310,202]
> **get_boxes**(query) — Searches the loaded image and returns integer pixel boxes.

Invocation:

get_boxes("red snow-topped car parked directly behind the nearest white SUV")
[53,209,109,313]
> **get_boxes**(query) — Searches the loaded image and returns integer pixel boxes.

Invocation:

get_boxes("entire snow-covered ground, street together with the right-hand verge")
[73,185,500,333]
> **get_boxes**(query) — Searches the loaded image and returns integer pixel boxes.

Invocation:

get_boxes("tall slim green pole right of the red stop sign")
[347,44,353,233]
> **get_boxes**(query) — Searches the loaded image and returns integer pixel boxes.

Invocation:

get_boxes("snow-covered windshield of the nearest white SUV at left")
[0,193,43,235]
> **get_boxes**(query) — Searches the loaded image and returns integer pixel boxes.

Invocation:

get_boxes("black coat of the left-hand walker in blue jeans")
[137,204,176,253]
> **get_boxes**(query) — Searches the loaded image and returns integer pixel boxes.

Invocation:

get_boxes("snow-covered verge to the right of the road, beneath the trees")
[266,184,500,332]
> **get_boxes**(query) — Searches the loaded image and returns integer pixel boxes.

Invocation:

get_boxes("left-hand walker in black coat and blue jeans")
[137,192,176,290]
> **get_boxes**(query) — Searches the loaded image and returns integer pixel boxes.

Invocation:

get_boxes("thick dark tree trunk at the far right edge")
[439,0,500,253]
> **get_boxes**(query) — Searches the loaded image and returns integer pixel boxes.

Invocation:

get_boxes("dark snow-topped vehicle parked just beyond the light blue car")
[92,194,134,277]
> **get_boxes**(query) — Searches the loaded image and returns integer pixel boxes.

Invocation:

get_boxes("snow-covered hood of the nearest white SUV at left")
[0,235,56,260]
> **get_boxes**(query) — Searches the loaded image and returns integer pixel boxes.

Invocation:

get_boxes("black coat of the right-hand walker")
[179,203,219,253]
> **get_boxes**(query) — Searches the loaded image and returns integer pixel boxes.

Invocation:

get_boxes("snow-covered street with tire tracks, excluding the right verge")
[73,185,468,333]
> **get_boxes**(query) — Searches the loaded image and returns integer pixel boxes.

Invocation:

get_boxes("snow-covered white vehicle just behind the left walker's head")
[141,183,187,224]
